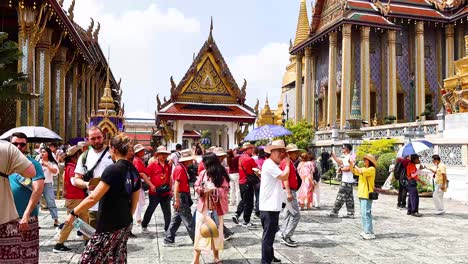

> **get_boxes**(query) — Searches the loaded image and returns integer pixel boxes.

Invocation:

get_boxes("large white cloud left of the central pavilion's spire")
[60,0,200,115]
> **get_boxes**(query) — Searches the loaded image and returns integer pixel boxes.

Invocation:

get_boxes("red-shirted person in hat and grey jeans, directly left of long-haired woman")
[164,149,197,245]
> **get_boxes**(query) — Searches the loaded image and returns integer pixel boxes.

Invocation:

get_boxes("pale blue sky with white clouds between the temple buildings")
[64,0,304,116]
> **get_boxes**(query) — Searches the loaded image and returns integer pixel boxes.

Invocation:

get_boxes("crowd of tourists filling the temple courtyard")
[0,127,447,263]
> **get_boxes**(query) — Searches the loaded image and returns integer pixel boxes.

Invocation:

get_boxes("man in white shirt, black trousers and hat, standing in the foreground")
[260,140,291,263]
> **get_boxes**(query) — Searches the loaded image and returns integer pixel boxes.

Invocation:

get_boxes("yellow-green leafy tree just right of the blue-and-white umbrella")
[285,120,314,149]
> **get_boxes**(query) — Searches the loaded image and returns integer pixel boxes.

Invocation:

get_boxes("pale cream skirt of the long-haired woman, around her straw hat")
[194,209,224,251]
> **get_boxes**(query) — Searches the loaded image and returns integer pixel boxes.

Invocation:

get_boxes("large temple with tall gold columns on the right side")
[282,0,468,129]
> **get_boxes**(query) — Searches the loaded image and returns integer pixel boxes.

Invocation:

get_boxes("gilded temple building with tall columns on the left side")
[0,0,122,140]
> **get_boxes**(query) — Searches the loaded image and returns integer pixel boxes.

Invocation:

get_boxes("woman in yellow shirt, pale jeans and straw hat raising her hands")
[350,154,377,240]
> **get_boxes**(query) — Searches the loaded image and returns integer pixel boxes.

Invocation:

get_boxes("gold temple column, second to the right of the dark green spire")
[387,30,398,119]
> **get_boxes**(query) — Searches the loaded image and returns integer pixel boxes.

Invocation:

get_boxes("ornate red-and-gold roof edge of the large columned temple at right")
[291,0,468,54]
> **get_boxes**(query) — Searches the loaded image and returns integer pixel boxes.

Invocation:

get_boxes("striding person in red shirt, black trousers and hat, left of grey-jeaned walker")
[141,146,172,233]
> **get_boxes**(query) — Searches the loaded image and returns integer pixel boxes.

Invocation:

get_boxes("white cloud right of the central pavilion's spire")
[228,43,289,109]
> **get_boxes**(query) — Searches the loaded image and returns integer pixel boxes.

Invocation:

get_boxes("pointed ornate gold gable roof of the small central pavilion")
[156,19,256,123]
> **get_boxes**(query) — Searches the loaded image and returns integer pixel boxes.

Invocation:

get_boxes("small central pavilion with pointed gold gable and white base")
[155,23,257,149]
